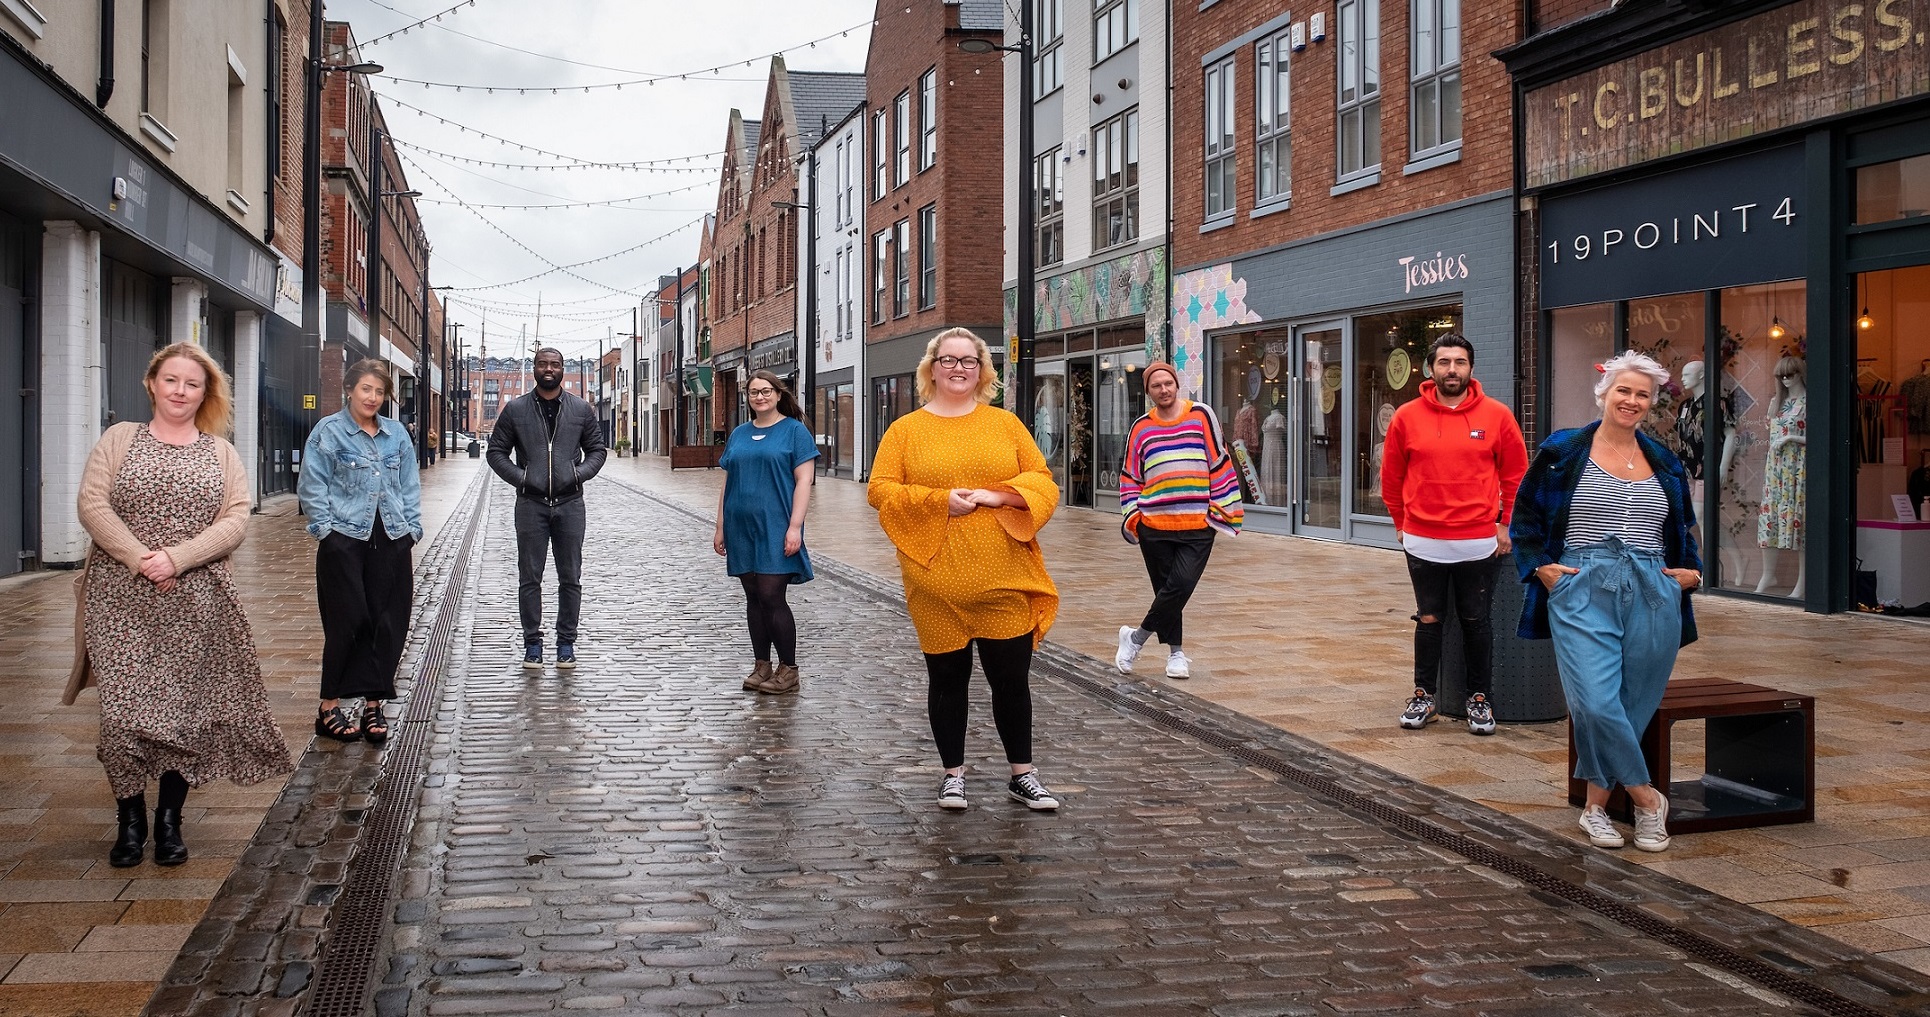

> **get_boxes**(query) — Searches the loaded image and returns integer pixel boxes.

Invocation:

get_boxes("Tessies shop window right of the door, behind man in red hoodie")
[1353,303,1480,515]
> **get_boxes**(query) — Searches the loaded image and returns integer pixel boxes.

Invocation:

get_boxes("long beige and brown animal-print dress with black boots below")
[87,425,293,799]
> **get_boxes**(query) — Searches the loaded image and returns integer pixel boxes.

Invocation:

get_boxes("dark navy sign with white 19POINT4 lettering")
[1540,147,1808,307]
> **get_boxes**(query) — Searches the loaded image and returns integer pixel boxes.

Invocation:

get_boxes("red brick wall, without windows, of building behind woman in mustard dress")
[857,2,1006,345]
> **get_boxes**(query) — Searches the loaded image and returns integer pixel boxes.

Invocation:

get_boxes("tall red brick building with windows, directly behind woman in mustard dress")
[853,0,1004,446]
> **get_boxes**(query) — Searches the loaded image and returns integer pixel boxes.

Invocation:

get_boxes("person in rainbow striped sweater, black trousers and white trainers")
[1112,363,1245,677]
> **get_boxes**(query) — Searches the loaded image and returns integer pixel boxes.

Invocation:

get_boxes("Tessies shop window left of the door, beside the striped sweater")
[1212,328,1289,506]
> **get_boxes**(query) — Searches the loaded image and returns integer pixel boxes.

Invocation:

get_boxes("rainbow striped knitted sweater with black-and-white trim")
[1119,401,1245,542]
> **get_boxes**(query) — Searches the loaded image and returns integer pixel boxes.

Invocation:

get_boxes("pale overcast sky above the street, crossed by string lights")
[326,0,874,355]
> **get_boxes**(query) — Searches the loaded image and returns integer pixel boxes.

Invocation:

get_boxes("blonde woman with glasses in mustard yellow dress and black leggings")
[869,328,1060,811]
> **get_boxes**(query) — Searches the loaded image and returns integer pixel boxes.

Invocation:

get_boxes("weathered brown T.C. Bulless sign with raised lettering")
[1523,0,1930,187]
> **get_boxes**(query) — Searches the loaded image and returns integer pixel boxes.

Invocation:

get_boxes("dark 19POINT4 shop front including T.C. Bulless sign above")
[1505,0,1930,614]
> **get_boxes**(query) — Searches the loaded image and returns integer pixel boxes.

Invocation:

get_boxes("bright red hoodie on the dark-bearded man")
[1380,378,1529,540]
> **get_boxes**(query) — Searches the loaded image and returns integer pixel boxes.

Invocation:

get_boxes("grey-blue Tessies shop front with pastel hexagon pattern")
[1172,197,1515,548]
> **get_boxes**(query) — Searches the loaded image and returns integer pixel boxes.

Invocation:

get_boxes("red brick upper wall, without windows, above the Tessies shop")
[1173,0,1521,268]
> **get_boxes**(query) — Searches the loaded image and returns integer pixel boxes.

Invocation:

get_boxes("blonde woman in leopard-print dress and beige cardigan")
[66,344,293,868]
